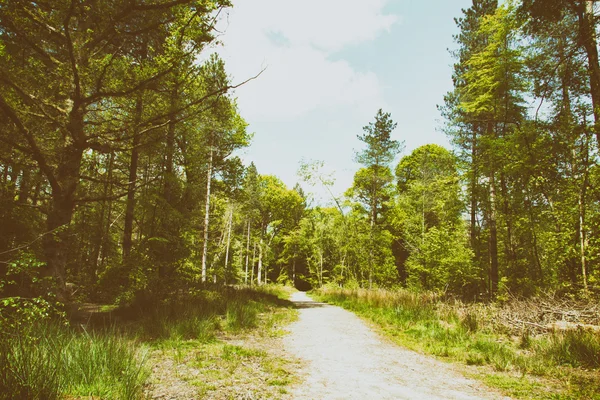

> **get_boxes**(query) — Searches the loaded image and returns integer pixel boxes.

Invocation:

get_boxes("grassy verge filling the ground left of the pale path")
[0,286,295,400]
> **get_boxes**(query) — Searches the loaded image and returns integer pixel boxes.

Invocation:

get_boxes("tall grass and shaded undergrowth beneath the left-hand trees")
[0,286,290,400]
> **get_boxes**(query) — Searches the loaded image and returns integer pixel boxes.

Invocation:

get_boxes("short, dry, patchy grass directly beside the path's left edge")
[146,286,297,398]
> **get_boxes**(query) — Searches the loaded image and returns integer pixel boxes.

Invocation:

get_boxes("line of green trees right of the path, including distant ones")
[288,0,600,298]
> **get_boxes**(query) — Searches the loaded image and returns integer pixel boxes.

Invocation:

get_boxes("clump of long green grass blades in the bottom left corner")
[0,321,148,399]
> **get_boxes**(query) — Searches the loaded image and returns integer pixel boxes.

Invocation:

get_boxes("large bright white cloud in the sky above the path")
[212,0,398,122]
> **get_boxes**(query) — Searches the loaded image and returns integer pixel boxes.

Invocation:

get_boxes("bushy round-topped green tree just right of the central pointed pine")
[390,145,481,297]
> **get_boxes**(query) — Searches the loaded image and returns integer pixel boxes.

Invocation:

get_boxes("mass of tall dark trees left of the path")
[0,0,251,301]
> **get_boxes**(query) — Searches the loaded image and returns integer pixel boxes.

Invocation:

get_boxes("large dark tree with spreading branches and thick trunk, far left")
[0,0,229,297]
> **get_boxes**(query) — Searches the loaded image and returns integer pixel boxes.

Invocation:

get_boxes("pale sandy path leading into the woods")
[284,292,506,400]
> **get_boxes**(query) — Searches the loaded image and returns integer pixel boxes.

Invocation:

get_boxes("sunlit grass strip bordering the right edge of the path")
[315,289,600,399]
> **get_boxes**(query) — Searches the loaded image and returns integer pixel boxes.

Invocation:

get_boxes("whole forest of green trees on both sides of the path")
[0,0,600,398]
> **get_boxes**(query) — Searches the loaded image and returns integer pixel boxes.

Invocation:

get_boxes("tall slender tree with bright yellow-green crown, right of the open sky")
[458,1,526,295]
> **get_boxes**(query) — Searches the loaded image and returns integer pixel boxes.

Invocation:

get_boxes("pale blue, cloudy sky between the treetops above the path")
[216,0,471,203]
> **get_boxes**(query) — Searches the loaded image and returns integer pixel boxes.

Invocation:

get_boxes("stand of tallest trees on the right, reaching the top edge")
[438,0,599,297]
